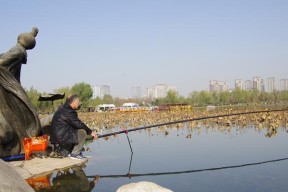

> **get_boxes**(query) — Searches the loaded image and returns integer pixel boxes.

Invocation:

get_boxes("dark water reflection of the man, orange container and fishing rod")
[28,154,288,192]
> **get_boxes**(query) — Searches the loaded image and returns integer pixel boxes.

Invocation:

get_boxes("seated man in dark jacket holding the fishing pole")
[50,95,97,159]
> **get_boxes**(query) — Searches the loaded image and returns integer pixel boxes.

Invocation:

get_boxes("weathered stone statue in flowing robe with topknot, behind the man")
[0,27,41,156]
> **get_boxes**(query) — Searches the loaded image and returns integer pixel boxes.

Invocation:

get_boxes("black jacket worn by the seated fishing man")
[50,103,92,144]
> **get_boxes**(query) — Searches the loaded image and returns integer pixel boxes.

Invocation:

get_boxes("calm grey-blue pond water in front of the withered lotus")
[31,128,288,192]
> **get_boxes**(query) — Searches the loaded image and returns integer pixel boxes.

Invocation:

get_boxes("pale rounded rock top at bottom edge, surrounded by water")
[116,181,173,192]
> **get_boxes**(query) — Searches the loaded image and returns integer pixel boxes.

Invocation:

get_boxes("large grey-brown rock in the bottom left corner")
[0,160,34,192]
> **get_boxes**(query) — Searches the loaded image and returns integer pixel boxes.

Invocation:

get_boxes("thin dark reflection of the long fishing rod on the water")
[87,157,288,178]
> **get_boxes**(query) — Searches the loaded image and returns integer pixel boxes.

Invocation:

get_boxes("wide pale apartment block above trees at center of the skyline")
[147,84,176,99]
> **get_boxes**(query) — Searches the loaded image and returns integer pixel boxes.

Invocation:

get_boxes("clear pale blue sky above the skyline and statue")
[0,0,288,97]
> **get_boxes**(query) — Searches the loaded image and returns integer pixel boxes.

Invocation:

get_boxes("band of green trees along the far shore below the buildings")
[25,82,288,113]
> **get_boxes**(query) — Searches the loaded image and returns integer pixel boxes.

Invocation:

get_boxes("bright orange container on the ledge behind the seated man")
[23,135,48,160]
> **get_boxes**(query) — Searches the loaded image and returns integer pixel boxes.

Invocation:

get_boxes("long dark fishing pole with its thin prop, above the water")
[98,108,288,138]
